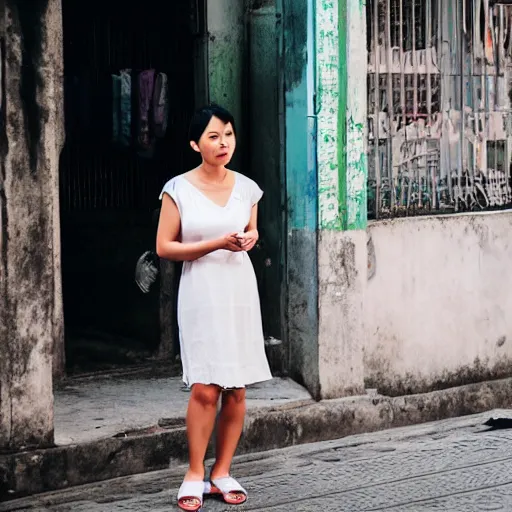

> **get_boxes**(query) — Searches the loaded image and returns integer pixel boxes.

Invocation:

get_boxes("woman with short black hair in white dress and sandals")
[157,105,272,511]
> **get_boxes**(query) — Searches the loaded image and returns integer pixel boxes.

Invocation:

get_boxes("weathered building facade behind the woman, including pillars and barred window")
[0,0,512,449]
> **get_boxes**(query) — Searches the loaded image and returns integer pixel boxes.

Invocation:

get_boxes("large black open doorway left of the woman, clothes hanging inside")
[60,0,197,372]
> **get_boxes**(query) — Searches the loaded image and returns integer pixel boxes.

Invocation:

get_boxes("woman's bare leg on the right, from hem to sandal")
[211,388,245,478]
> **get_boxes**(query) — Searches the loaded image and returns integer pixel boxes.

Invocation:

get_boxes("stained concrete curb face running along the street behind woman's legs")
[0,378,512,501]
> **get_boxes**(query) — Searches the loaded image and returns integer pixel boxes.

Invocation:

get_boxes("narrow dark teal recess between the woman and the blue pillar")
[246,2,290,375]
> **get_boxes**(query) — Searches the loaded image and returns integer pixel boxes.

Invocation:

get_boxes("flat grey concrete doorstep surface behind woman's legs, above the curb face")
[55,375,312,446]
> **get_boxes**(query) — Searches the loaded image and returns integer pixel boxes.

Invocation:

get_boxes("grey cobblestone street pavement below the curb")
[4,413,512,512]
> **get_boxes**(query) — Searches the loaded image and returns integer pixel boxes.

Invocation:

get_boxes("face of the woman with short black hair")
[190,117,236,166]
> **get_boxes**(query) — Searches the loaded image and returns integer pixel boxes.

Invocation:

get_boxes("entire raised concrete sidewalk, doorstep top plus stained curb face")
[0,374,512,501]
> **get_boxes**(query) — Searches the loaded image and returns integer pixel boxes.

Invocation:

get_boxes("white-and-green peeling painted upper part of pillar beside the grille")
[315,0,368,230]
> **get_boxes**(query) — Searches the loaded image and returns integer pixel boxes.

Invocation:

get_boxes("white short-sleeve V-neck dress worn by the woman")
[160,173,272,388]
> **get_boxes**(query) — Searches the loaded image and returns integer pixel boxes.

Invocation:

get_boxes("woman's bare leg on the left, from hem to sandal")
[185,384,221,480]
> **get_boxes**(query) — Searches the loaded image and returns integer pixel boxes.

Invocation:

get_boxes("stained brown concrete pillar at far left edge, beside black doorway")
[0,0,63,449]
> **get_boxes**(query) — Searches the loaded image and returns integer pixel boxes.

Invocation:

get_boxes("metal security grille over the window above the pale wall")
[367,0,512,218]
